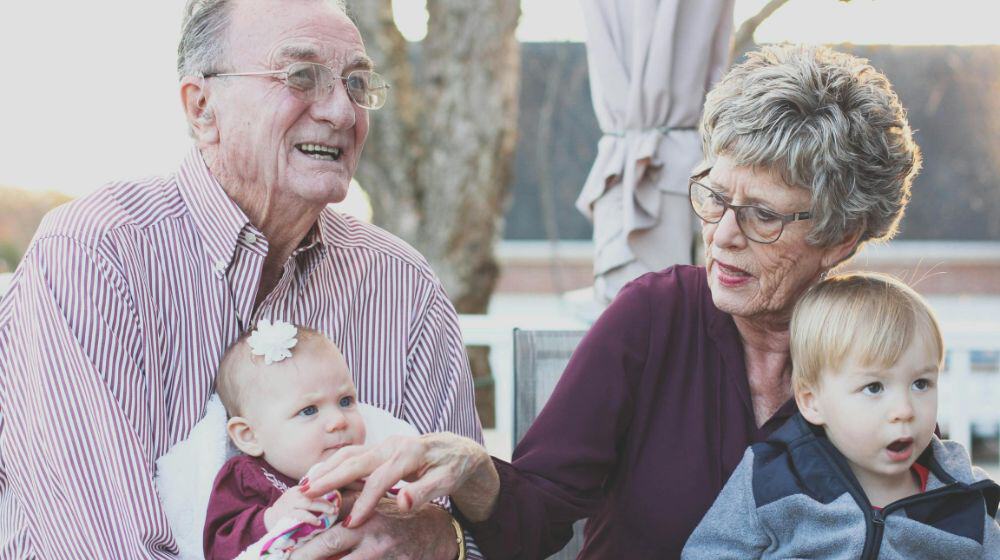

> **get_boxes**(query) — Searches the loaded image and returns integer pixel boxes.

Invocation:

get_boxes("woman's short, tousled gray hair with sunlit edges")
[701,45,921,250]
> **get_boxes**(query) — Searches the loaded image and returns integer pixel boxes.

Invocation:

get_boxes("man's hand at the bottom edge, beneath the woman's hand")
[292,499,458,560]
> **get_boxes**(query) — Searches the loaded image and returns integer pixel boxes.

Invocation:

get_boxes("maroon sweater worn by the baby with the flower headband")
[204,455,297,560]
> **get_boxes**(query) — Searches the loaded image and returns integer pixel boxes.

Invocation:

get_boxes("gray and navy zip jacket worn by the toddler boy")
[681,414,1000,560]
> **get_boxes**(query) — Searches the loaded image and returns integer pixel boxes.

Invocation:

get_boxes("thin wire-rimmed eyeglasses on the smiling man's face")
[205,62,389,110]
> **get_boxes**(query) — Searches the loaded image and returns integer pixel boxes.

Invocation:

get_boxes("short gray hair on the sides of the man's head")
[177,0,347,78]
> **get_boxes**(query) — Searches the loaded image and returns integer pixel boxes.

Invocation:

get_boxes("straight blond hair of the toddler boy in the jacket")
[789,273,944,392]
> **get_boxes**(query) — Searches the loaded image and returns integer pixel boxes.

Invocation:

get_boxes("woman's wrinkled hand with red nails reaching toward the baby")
[305,432,500,528]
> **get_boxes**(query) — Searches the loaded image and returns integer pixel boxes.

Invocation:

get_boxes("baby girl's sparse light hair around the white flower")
[215,325,329,416]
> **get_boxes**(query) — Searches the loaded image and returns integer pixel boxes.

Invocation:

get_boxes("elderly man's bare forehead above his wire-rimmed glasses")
[227,0,371,68]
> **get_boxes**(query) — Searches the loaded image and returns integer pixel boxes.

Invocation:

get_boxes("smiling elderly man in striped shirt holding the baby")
[0,0,482,558]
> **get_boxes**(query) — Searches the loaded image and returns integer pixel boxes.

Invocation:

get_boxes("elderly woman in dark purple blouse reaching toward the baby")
[298,46,920,559]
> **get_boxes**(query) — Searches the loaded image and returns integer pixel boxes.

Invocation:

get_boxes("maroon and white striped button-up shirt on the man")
[0,150,482,558]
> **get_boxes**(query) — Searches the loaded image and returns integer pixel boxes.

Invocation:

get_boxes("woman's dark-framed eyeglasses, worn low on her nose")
[688,171,812,243]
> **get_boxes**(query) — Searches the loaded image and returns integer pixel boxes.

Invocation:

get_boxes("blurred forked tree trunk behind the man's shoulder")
[349,0,520,313]
